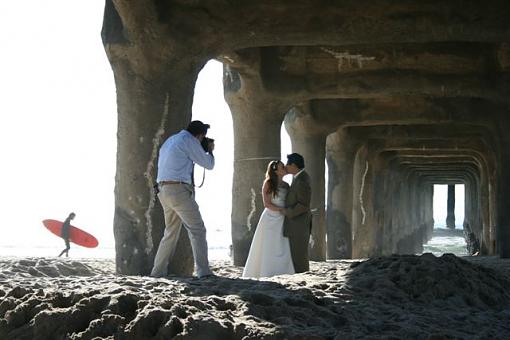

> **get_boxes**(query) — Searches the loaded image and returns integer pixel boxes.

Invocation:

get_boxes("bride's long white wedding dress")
[243,187,295,278]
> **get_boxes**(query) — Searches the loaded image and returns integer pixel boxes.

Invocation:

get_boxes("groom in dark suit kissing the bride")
[283,153,312,273]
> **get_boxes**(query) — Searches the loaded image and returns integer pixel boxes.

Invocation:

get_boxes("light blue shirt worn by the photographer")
[157,130,214,184]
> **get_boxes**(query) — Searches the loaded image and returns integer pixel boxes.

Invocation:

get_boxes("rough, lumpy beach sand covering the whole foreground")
[0,254,510,340]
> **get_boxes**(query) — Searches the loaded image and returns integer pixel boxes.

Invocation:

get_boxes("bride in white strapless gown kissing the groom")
[243,161,295,278]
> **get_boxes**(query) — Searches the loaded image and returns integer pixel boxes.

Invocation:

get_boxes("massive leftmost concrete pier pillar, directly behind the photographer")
[102,1,207,275]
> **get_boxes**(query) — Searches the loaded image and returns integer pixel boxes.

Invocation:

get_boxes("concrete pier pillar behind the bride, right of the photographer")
[223,64,289,266]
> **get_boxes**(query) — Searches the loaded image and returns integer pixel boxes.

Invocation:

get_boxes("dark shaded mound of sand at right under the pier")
[350,254,510,309]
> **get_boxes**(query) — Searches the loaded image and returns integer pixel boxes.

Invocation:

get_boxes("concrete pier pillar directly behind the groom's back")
[285,107,327,261]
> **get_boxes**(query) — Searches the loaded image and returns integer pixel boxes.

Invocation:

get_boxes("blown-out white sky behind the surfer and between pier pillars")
[0,0,462,254]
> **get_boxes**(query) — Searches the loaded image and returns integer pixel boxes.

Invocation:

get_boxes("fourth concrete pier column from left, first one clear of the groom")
[326,129,358,259]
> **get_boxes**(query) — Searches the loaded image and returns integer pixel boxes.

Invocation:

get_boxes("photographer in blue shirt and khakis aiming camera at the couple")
[151,120,214,277]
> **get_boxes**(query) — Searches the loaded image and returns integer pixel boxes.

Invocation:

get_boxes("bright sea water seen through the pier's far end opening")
[423,226,468,256]
